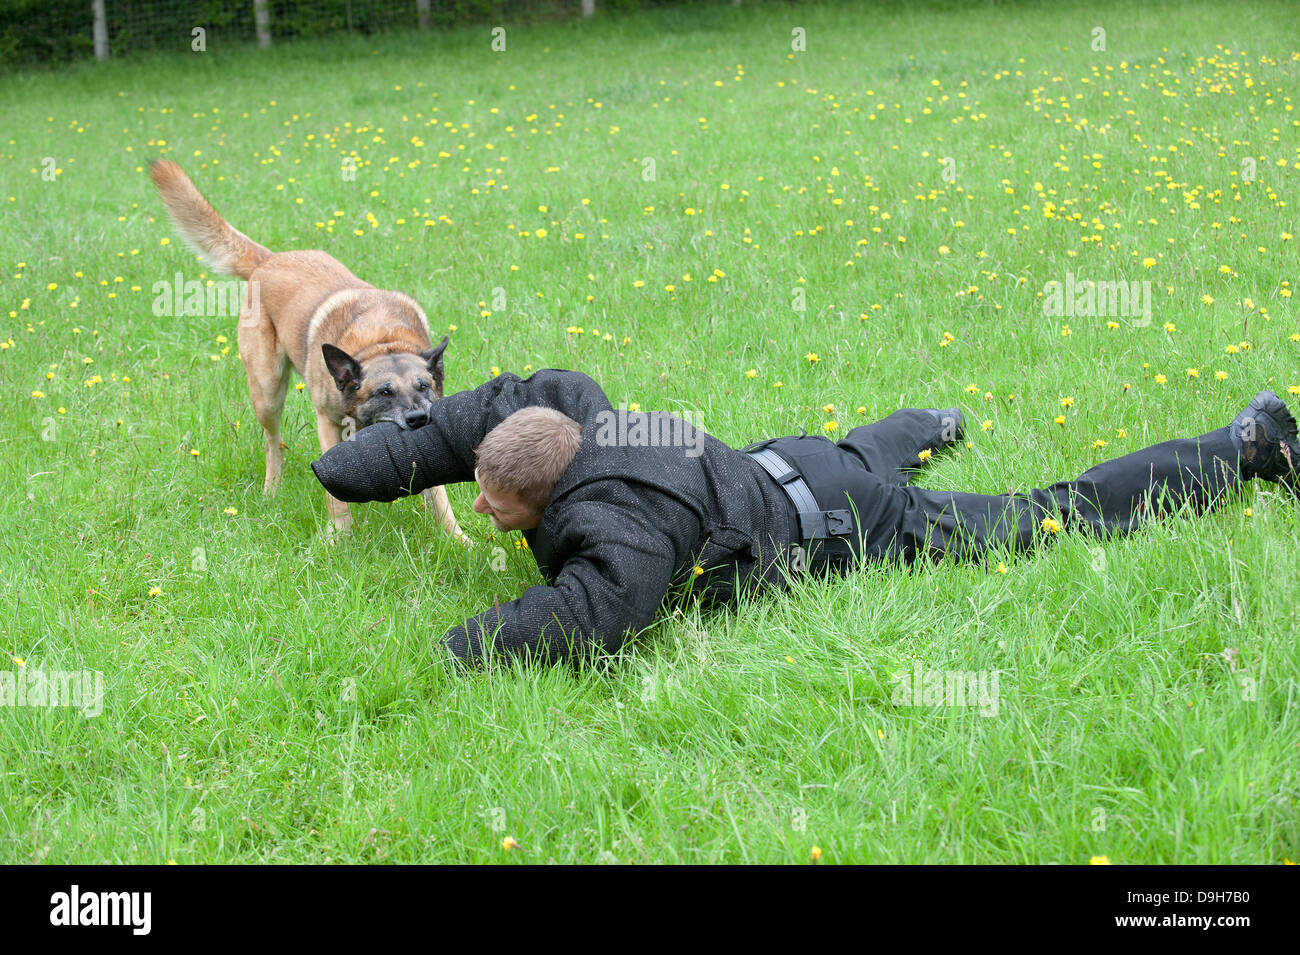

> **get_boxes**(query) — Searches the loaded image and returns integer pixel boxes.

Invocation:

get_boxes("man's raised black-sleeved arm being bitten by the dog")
[312,369,610,503]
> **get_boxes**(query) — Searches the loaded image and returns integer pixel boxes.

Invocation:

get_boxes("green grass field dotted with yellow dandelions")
[0,0,1300,864]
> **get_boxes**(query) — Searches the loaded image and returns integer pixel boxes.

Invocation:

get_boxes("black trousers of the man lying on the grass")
[770,408,1243,567]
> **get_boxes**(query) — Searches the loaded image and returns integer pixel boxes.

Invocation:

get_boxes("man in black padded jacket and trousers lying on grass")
[312,370,1300,663]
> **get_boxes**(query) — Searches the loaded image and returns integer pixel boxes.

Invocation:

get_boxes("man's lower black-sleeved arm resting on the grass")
[442,487,694,665]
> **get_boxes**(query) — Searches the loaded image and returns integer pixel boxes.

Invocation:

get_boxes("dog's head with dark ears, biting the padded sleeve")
[321,335,449,429]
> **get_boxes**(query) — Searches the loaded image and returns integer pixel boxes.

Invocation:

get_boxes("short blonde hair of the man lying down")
[475,407,582,509]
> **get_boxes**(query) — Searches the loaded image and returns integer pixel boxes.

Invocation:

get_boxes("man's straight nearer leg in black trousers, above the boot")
[850,427,1243,561]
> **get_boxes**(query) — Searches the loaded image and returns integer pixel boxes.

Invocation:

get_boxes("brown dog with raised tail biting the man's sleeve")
[150,160,465,541]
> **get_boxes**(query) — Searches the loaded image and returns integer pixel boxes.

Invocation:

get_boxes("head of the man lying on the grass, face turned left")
[475,408,582,530]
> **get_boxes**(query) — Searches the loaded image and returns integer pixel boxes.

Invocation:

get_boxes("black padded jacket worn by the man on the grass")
[312,369,793,664]
